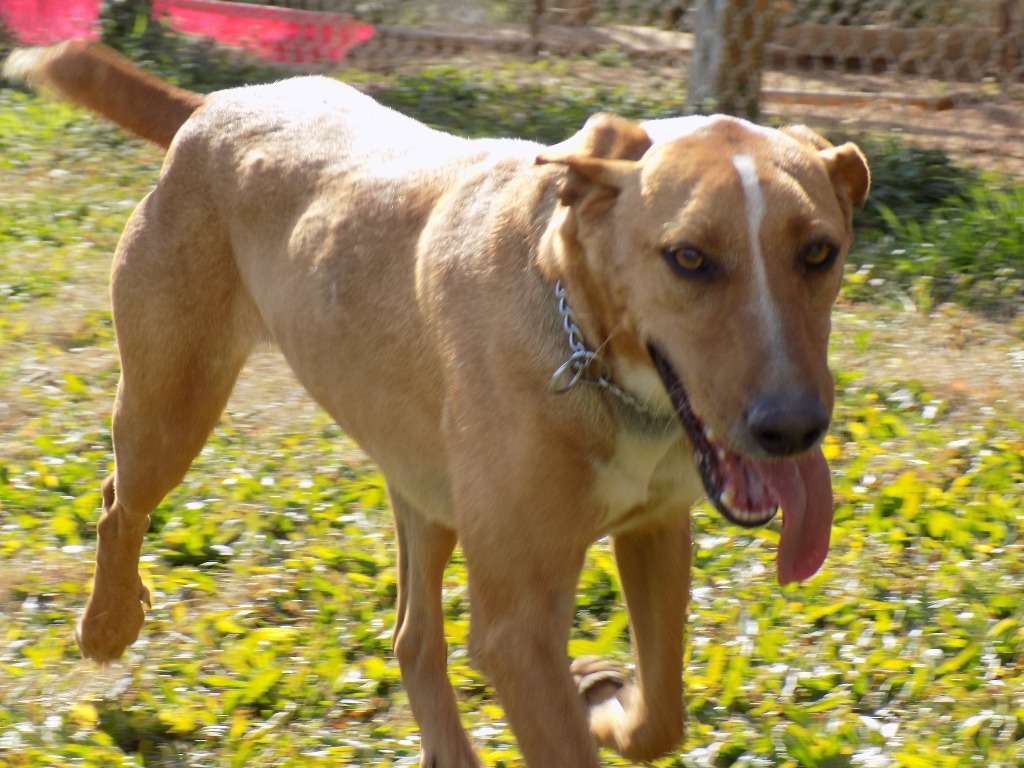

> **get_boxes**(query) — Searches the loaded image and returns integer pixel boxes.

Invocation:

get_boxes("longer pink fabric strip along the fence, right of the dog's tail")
[149,0,374,63]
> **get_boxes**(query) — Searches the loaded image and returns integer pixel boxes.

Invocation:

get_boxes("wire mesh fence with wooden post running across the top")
[0,0,1024,173]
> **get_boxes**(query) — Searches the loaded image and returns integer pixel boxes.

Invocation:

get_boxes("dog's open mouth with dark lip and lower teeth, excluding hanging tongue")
[647,345,780,527]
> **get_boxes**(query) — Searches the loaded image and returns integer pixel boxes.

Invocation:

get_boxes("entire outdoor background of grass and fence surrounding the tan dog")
[0,0,1024,768]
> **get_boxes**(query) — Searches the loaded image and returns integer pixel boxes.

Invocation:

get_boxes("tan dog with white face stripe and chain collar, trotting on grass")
[8,44,868,768]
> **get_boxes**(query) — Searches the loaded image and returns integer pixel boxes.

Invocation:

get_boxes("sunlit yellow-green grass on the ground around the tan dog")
[0,61,1024,768]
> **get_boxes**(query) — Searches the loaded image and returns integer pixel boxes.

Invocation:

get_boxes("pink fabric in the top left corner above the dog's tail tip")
[0,0,100,45]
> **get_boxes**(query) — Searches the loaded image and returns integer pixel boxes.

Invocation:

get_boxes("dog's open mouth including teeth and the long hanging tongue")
[647,344,833,584]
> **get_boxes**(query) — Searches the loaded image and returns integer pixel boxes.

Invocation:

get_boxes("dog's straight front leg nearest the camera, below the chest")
[457,456,598,768]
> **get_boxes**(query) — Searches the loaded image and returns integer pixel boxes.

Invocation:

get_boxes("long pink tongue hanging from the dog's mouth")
[757,447,833,584]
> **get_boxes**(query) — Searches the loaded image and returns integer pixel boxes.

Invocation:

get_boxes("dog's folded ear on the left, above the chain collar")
[537,113,652,206]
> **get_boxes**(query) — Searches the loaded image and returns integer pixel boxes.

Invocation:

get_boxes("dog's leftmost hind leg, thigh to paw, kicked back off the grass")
[78,192,258,662]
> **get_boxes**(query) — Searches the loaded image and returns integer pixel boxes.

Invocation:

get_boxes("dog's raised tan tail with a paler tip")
[3,40,204,148]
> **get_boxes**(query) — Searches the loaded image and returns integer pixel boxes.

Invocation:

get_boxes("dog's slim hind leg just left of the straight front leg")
[388,487,479,768]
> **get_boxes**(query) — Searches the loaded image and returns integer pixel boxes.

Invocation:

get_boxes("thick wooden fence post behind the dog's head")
[686,0,773,120]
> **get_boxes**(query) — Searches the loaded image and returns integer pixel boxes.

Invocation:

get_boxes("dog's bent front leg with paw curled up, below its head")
[573,516,691,761]
